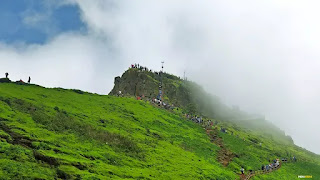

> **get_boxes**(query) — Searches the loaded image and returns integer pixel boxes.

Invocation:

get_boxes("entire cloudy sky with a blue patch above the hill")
[0,0,320,154]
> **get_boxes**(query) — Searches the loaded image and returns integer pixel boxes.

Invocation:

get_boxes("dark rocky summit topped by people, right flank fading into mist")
[109,67,250,119]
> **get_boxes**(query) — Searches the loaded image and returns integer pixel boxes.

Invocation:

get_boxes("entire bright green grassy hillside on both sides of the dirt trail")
[0,83,320,180]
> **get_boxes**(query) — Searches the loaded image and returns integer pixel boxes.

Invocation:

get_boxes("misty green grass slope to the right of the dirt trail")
[217,121,320,176]
